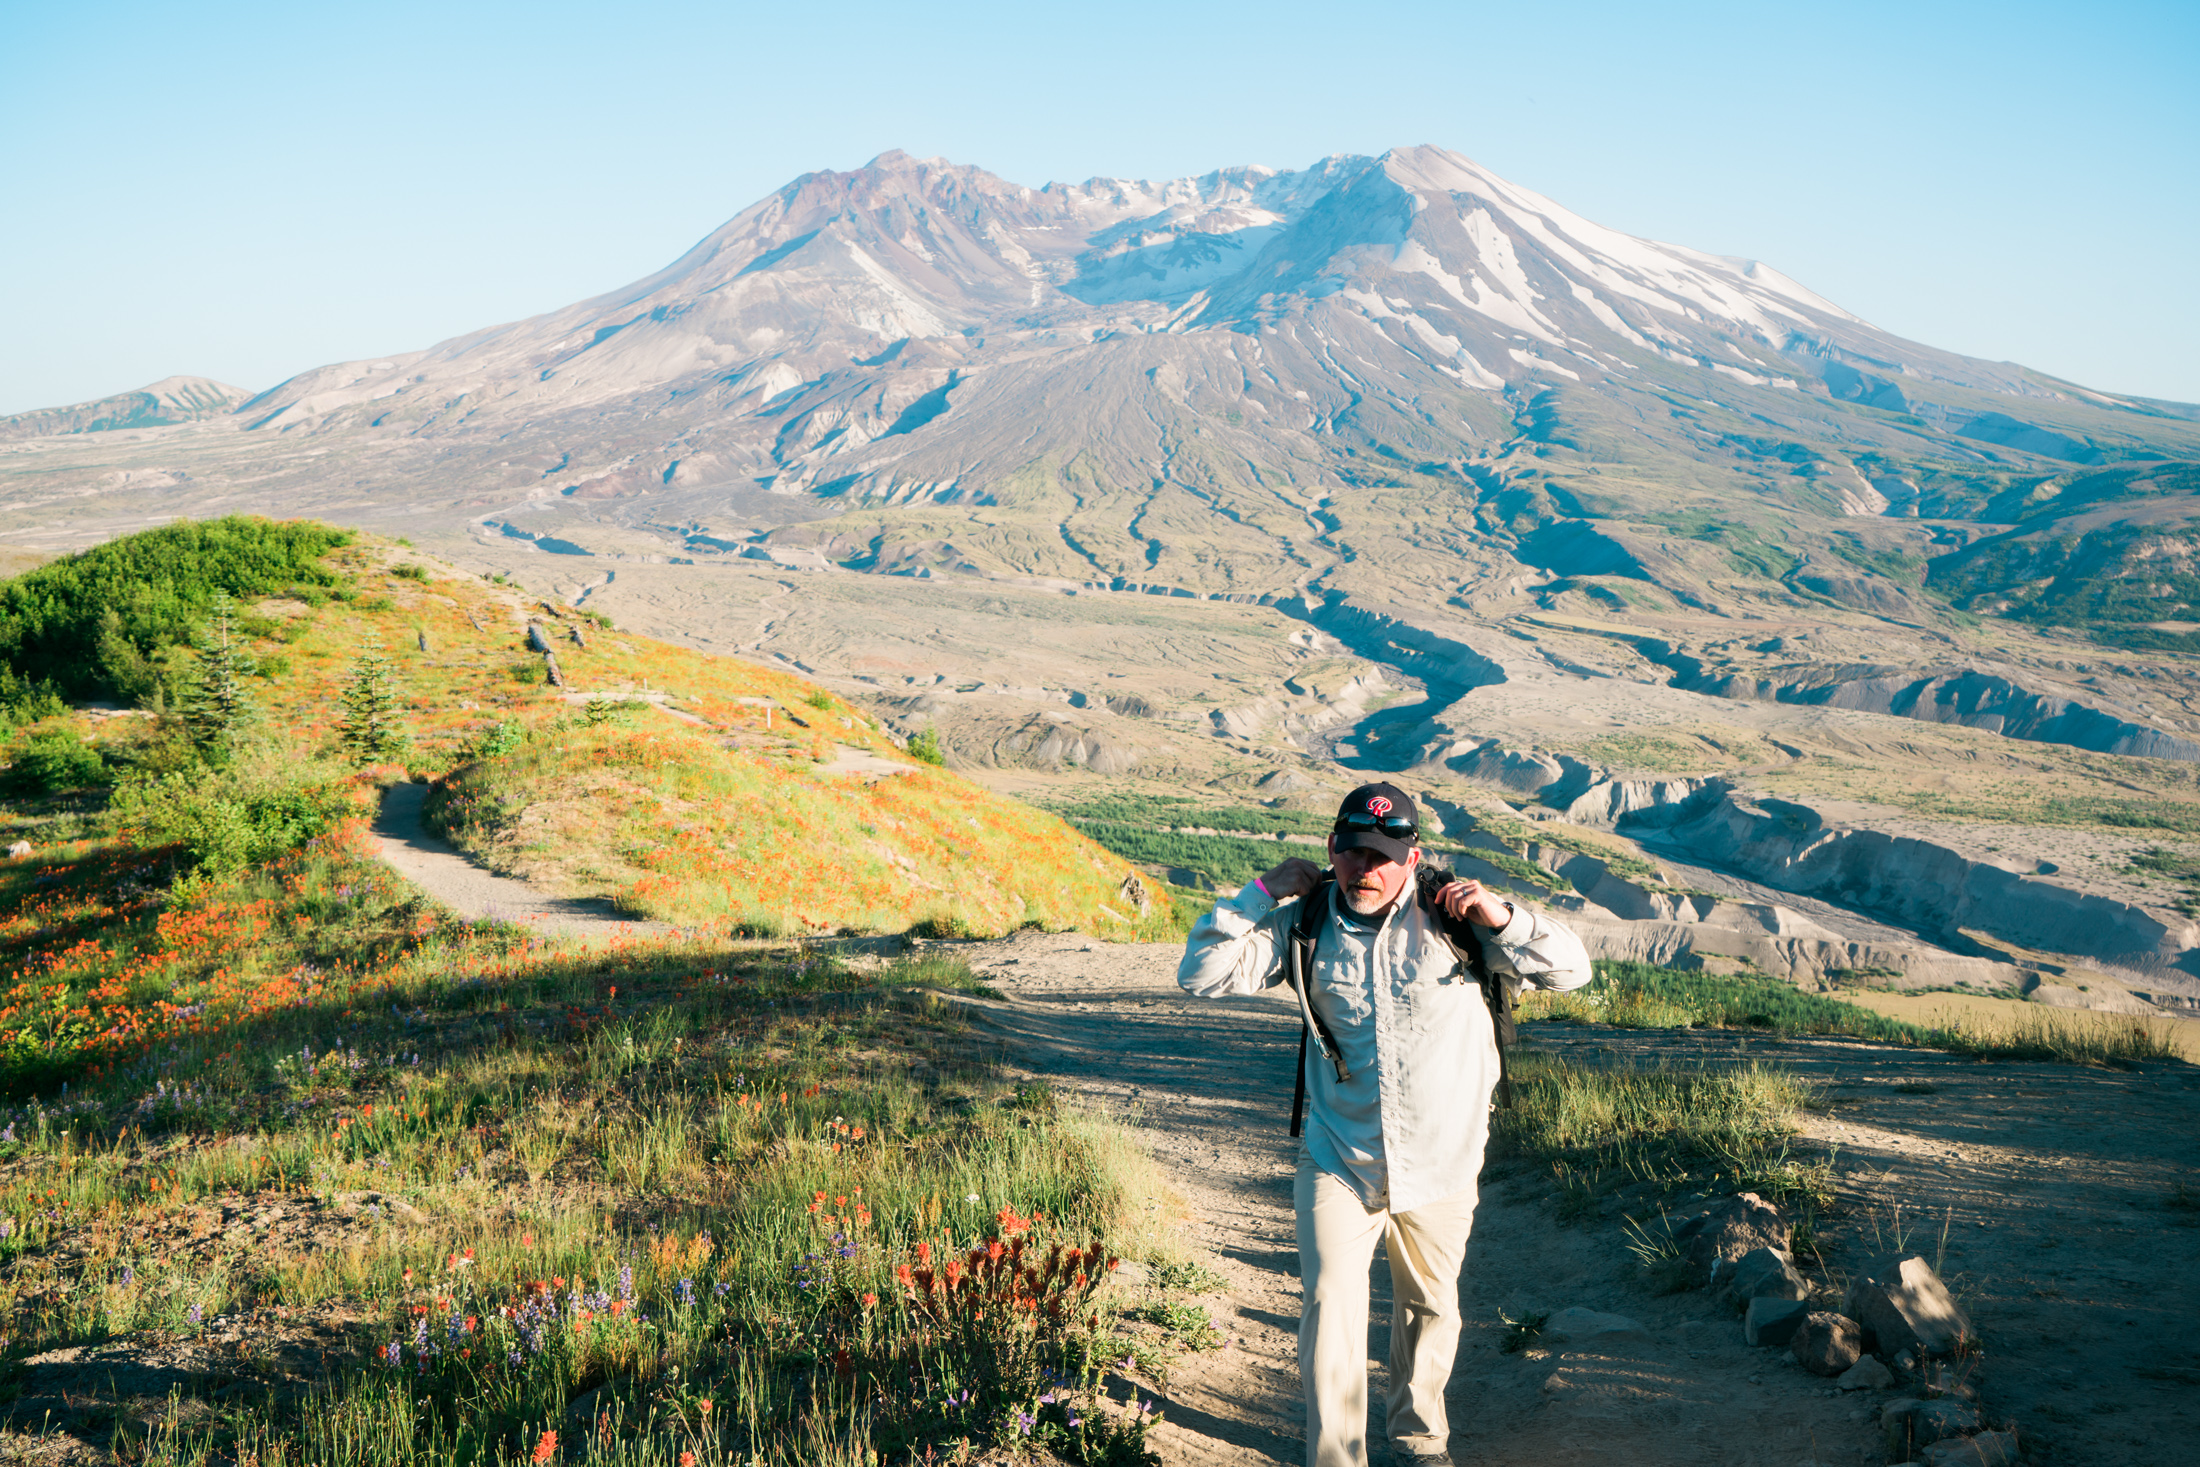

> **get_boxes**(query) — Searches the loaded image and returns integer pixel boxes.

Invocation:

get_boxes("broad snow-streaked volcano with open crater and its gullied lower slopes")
[0,147,2200,796]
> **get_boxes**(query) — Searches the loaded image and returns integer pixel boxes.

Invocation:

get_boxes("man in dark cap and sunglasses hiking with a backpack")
[1177,783,1588,1467]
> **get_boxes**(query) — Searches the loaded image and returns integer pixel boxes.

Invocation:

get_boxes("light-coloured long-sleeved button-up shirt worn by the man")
[1177,882,1591,1212]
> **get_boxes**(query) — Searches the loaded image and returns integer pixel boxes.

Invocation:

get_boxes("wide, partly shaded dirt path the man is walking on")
[941,935,2200,1467]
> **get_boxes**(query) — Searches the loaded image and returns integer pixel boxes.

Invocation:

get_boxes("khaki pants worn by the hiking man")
[1296,1152,1476,1467]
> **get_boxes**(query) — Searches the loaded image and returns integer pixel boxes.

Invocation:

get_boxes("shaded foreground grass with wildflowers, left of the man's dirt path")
[0,858,1206,1467]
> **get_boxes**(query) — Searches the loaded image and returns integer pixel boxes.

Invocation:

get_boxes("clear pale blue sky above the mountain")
[0,0,2200,411]
